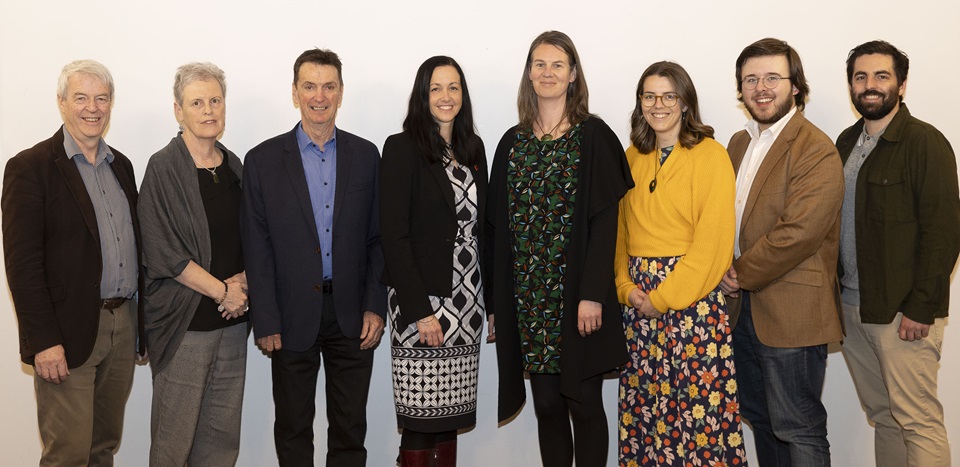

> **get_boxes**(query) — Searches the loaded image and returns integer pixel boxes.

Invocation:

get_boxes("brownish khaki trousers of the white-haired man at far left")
[34,300,136,467]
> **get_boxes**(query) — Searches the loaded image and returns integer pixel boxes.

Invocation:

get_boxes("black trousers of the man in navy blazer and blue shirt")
[272,294,374,467]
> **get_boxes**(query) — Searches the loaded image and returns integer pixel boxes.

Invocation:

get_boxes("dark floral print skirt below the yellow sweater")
[618,256,747,467]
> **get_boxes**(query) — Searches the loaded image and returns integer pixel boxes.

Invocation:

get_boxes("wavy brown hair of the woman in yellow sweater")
[630,62,713,154]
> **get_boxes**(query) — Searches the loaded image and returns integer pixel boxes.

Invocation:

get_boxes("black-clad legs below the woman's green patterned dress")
[530,374,609,467]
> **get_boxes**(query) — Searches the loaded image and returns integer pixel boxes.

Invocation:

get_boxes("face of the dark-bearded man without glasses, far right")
[850,54,907,120]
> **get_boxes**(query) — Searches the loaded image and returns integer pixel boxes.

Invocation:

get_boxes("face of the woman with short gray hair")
[173,80,227,141]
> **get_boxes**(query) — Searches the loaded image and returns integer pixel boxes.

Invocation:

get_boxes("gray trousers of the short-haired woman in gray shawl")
[150,323,248,467]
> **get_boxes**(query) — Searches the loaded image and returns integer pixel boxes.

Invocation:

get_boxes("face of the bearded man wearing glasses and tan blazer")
[740,55,800,131]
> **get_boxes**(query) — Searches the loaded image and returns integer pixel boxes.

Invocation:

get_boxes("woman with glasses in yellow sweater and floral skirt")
[615,62,746,466]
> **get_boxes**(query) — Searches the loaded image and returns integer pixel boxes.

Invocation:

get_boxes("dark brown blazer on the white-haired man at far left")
[0,127,143,368]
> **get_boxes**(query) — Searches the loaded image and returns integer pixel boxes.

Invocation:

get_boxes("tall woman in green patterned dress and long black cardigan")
[485,31,633,467]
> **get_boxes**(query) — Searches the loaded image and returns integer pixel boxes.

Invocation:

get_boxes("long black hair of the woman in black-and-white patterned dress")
[403,55,480,166]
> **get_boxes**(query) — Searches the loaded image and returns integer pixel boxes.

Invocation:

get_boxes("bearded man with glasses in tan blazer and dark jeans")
[721,39,843,466]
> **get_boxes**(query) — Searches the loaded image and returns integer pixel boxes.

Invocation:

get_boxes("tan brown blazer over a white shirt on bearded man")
[727,112,843,347]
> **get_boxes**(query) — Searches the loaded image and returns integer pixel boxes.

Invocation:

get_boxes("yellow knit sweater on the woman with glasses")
[615,138,736,313]
